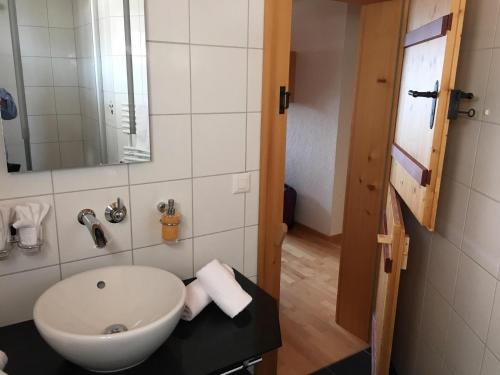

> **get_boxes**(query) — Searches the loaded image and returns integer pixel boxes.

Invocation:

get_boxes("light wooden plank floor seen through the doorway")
[278,228,368,375]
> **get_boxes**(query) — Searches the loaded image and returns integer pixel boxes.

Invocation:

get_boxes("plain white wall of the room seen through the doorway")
[286,0,356,235]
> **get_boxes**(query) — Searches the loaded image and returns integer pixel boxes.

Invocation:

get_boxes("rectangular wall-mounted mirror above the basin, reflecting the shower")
[0,0,150,172]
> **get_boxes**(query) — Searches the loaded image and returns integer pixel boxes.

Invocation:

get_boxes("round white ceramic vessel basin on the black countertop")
[34,266,186,372]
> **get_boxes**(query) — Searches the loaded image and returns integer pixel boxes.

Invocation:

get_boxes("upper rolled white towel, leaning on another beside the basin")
[196,259,252,318]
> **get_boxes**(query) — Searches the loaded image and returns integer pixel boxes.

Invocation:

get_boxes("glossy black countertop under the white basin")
[0,272,281,375]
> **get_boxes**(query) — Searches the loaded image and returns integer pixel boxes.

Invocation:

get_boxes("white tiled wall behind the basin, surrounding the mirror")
[0,0,264,326]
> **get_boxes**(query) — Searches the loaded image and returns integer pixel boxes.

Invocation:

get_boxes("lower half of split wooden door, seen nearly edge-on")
[371,186,409,375]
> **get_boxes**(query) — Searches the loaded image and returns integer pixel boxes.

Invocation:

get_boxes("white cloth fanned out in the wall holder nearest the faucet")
[12,203,50,246]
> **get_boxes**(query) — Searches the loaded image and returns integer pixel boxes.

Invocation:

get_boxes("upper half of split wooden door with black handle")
[390,0,466,230]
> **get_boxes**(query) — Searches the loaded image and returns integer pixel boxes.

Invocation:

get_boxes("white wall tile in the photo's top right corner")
[462,0,499,49]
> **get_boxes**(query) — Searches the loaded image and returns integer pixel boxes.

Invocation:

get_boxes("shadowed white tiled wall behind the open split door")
[393,0,500,375]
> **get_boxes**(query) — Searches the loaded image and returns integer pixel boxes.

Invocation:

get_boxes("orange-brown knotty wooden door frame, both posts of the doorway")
[258,0,407,374]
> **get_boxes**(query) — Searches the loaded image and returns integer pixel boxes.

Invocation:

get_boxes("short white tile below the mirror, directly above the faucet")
[52,165,128,193]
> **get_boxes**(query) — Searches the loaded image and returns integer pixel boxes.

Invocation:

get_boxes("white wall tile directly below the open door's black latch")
[444,118,481,186]
